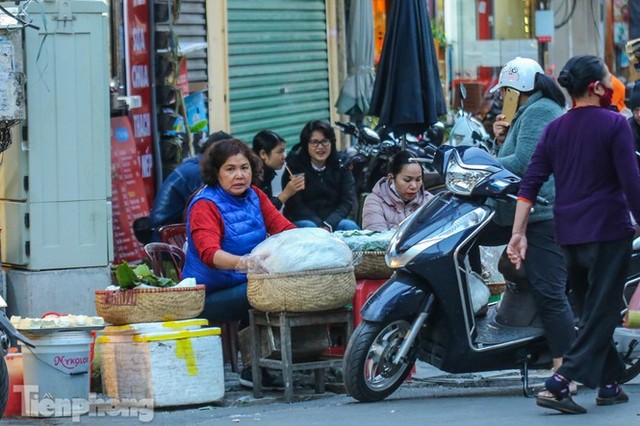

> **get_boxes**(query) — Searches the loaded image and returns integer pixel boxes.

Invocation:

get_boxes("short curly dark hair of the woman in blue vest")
[200,139,262,186]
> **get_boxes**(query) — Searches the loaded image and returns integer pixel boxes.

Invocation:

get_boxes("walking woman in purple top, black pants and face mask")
[507,55,640,414]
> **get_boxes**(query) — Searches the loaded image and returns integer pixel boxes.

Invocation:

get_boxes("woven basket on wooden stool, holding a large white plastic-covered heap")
[247,266,356,312]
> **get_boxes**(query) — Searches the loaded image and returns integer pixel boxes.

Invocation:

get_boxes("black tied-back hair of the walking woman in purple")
[558,55,607,98]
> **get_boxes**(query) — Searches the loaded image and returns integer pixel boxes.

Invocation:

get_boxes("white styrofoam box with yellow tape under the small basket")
[96,320,224,407]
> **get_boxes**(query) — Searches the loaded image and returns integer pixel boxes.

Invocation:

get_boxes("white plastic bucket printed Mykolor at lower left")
[20,331,92,417]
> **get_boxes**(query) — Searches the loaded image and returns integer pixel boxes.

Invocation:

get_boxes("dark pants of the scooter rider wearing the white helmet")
[469,220,576,358]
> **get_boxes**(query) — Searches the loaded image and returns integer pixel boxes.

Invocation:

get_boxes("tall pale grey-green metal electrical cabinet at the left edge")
[0,0,112,270]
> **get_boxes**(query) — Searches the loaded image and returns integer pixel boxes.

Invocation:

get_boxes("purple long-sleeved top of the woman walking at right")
[519,106,640,245]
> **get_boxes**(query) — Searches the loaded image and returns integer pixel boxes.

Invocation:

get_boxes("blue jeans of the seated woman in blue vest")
[200,283,251,325]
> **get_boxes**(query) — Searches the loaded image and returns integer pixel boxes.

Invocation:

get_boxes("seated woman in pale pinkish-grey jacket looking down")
[362,151,433,231]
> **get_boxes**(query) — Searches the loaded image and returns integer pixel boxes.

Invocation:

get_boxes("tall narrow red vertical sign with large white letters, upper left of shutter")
[124,0,155,204]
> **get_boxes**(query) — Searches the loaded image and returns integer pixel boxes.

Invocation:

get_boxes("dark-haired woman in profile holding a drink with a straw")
[253,130,304,210]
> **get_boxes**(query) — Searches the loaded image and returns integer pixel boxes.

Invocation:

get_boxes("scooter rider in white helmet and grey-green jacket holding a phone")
[472,57,575,382]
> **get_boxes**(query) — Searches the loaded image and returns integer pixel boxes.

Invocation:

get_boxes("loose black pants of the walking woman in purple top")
[558,237,631,388]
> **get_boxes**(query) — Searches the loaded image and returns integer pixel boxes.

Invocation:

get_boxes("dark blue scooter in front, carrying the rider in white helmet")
[343,145,640,402]
